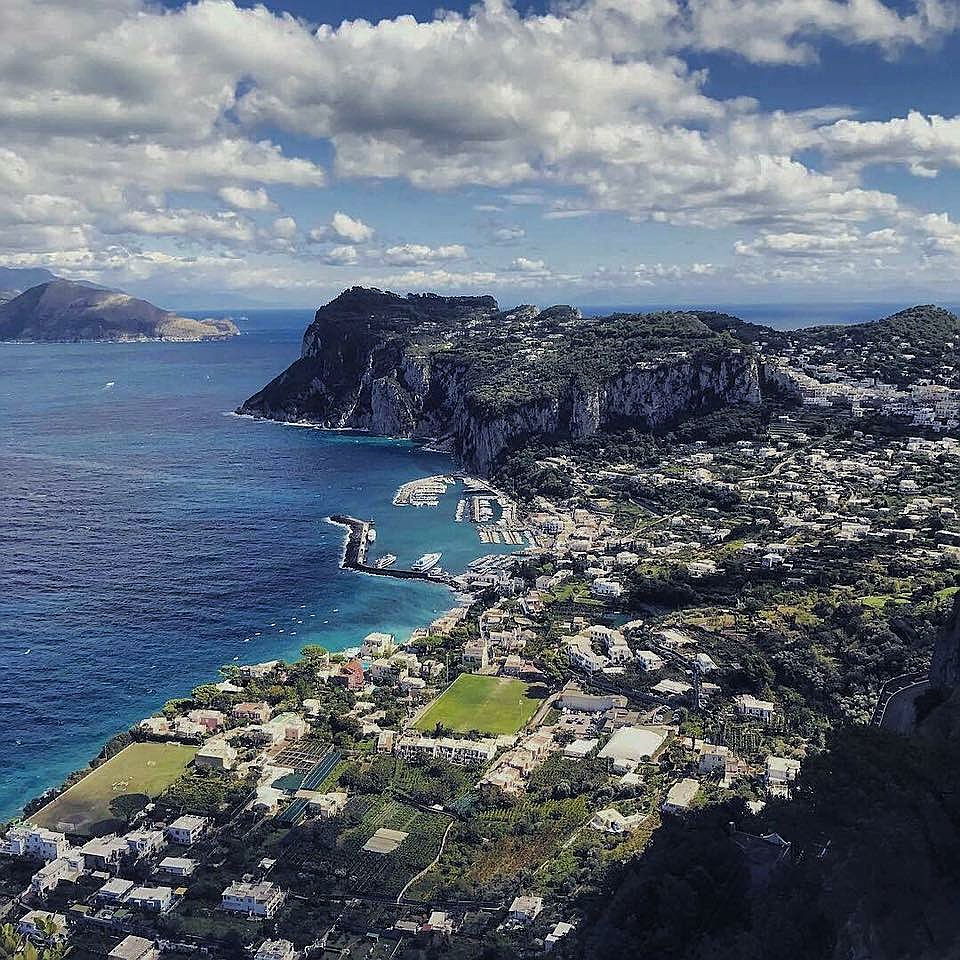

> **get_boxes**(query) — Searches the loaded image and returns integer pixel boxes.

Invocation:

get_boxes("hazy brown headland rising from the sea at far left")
[0,279,239,341]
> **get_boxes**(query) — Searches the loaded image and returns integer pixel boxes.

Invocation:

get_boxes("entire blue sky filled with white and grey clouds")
[0,0,960,308]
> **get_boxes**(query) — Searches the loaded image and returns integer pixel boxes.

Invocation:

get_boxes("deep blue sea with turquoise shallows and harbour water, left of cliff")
[0,311,516,819]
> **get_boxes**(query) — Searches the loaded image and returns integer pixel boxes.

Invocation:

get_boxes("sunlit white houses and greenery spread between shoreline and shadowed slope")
[0,394,960,960]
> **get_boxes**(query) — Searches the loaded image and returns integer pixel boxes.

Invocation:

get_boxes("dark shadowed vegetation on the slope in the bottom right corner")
[560,728,960,960]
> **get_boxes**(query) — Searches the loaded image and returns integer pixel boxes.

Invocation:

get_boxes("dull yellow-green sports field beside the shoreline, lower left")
[30,743,197,834]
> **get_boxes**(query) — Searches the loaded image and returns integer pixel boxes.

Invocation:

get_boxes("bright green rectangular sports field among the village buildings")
[416,673,543,734]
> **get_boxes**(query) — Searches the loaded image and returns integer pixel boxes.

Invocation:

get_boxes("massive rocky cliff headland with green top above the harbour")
[238,288,759,473]
